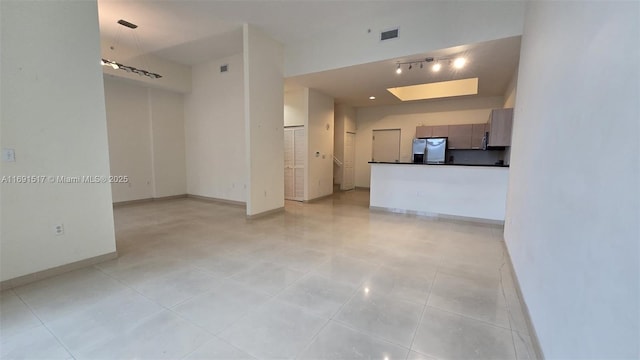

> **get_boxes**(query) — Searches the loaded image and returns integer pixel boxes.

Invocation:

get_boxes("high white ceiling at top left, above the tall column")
[98,0,412,65]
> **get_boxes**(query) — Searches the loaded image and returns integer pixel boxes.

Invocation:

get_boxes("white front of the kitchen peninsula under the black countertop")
[370,162,509,224]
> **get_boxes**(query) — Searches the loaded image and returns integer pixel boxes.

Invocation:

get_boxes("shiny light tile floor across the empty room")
[0,191,534,359]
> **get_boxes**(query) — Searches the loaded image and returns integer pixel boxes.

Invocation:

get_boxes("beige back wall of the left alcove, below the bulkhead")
[104,76,187,202]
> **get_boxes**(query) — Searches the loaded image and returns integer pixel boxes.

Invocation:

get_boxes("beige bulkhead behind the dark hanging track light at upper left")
[101,40,191,93]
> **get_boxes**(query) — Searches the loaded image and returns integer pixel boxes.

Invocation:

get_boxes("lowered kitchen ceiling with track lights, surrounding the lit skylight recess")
[285,36,521,107]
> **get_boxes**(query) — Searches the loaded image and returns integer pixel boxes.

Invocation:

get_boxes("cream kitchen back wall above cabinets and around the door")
[355,96,504,187]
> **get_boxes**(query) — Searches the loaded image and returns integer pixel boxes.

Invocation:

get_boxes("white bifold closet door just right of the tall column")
[284,127,306,201]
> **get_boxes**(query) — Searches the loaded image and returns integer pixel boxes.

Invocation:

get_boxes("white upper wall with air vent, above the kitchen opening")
[285,1,524,77]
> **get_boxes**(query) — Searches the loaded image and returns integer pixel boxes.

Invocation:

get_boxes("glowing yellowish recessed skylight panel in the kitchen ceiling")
[387,78,478,101]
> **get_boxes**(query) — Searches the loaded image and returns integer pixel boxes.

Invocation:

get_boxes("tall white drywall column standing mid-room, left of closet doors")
[243,24,284,216]
